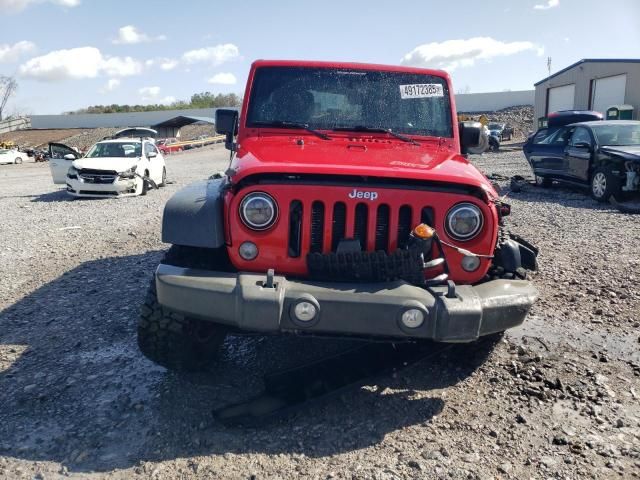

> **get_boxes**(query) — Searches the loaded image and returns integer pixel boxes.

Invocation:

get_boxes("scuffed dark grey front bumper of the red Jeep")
[156,264,537,342]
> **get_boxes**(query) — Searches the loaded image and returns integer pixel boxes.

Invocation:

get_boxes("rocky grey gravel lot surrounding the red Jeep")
[0,147,640,479]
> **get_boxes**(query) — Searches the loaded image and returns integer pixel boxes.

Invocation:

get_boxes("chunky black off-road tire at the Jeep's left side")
[138,246,227,372]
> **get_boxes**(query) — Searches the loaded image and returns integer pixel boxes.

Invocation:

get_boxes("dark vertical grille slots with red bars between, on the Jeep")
[288,200,433,258]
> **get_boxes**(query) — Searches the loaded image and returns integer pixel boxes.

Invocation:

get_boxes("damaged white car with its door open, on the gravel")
[49,128,167,198]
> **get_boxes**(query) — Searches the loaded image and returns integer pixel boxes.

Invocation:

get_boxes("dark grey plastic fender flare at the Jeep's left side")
[162,178,227,248]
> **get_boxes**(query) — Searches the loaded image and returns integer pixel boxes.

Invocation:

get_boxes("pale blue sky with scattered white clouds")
[0,0,640,114]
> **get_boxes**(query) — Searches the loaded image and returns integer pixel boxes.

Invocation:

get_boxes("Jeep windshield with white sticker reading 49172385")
[247,67,453,137]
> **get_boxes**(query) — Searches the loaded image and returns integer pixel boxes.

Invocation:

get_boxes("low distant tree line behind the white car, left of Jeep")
[68,92,242,114]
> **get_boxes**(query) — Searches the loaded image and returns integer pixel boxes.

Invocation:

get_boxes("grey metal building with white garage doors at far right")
[535,58,640,123]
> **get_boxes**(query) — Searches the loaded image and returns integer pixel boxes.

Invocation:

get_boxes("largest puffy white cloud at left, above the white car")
[19,47,142,82]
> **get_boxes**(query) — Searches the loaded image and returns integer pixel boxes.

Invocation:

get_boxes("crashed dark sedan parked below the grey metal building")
[523,120,640,202]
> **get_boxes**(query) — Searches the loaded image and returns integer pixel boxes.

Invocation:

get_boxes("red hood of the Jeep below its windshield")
[231,136,497,197]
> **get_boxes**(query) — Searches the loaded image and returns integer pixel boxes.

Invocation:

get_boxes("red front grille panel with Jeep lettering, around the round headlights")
[230,182,497,283]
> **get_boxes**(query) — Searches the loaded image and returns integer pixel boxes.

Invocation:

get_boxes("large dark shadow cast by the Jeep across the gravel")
[0,252,493,472]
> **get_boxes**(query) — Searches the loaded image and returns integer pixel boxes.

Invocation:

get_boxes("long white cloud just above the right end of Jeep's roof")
[401,37,544,72]
